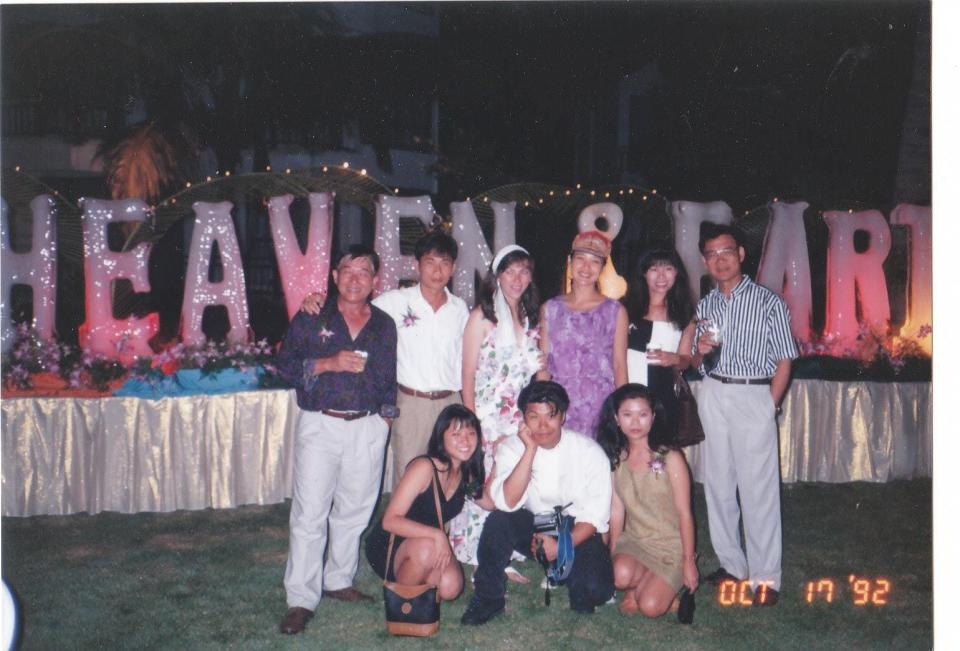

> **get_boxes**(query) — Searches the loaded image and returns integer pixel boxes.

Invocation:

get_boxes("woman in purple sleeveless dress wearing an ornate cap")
[537,231,628,438]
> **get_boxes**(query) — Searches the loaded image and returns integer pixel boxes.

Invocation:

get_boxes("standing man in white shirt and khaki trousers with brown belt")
[373,231,469,488]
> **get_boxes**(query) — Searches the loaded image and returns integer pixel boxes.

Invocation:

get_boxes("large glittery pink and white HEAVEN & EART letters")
[0,192,933,361]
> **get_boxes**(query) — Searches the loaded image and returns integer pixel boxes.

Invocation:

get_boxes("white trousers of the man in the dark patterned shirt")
[283,411,387,610]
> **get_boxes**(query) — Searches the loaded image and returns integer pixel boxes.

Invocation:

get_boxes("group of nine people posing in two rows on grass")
[279,224,797,634]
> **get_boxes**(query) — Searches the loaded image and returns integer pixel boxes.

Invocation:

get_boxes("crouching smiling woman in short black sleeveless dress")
[366,405,484,601]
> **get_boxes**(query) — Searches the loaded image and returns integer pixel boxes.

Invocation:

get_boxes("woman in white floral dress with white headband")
[450,244,542,575]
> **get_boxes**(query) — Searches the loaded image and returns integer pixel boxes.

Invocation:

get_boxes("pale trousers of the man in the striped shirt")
[697,377,782,590]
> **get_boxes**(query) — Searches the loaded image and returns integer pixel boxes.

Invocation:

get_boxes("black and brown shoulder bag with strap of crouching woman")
[383,460,443,637]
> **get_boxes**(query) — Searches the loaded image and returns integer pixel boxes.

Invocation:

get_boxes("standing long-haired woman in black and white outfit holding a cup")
[624,247,695,440]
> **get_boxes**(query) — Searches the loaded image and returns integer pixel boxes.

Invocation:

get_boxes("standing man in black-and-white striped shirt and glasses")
[693,223,797,606]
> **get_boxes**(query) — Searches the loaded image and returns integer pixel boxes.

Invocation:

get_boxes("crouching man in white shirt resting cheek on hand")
[461,381,613,625]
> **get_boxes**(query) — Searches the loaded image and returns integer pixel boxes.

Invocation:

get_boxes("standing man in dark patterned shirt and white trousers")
[278,245,397,634]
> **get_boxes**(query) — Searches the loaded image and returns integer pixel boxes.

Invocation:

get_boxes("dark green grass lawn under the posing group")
[2,480,933,651]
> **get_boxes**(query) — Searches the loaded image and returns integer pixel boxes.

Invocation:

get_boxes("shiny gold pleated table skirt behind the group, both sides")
[0,380,933,516]
